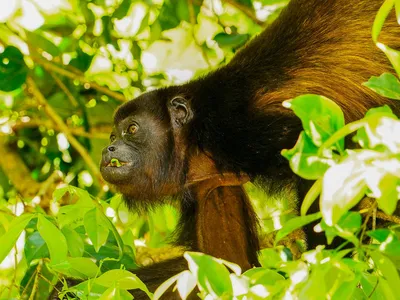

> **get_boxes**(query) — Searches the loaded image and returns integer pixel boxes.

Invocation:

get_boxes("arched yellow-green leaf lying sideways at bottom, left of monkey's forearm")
[94,270,151,295]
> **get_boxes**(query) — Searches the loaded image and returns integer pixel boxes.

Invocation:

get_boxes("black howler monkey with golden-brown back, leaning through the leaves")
[101,0,400,299]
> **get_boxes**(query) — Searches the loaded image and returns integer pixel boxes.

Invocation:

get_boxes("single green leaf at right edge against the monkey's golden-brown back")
[363,73,400,100]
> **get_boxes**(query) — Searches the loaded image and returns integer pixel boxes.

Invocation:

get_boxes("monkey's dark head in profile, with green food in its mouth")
[100,87,193,207]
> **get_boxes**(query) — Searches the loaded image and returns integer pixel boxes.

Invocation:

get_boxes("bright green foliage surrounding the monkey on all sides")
[0,0,400,299]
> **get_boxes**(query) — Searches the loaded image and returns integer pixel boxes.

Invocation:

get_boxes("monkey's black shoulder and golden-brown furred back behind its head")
[189,0,400,177]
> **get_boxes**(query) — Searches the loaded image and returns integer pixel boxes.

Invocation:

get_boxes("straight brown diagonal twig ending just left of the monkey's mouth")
[26,77,104,186]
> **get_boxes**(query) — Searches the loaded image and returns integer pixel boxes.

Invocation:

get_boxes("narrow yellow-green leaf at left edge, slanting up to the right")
[0,214,33,263]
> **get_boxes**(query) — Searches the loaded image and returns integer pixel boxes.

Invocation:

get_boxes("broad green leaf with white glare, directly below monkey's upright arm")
[184,252,233,297]
